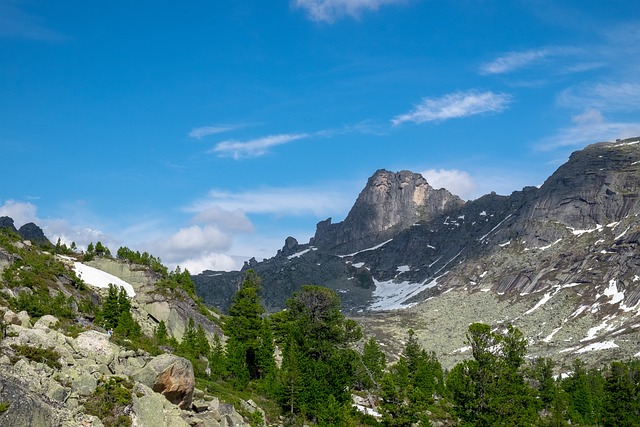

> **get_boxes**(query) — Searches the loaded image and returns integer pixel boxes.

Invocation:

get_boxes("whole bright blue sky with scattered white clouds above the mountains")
[0,0,640,272]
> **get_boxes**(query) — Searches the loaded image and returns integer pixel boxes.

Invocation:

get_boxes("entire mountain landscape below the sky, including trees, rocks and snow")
[0,138,640,427]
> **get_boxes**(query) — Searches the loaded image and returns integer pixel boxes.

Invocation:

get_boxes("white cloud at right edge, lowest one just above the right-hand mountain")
[537,108,640,151]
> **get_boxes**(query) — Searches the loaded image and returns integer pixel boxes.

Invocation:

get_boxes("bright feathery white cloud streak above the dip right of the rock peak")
[391,90,511,126]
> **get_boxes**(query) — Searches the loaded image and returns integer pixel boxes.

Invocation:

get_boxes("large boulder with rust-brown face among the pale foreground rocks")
[133,354,195,409]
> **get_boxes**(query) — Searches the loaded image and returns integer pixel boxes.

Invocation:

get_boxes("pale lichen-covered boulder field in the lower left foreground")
[0,307,264,427]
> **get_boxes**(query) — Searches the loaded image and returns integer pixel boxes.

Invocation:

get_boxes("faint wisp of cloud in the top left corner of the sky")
[0,1,67,42]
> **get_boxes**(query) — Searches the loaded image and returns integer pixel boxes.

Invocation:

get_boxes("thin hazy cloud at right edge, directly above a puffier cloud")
[558,82,640,111]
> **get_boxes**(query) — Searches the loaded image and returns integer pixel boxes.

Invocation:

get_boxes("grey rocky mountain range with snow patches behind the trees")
[194,138,640,372]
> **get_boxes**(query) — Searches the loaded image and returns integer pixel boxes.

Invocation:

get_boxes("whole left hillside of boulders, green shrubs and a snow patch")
[0,236,265,427]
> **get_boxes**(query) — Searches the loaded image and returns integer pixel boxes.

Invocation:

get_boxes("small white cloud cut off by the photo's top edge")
[291,0,406,23]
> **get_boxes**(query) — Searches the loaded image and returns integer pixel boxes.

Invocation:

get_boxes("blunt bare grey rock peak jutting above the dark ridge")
[313,169,464,254]
